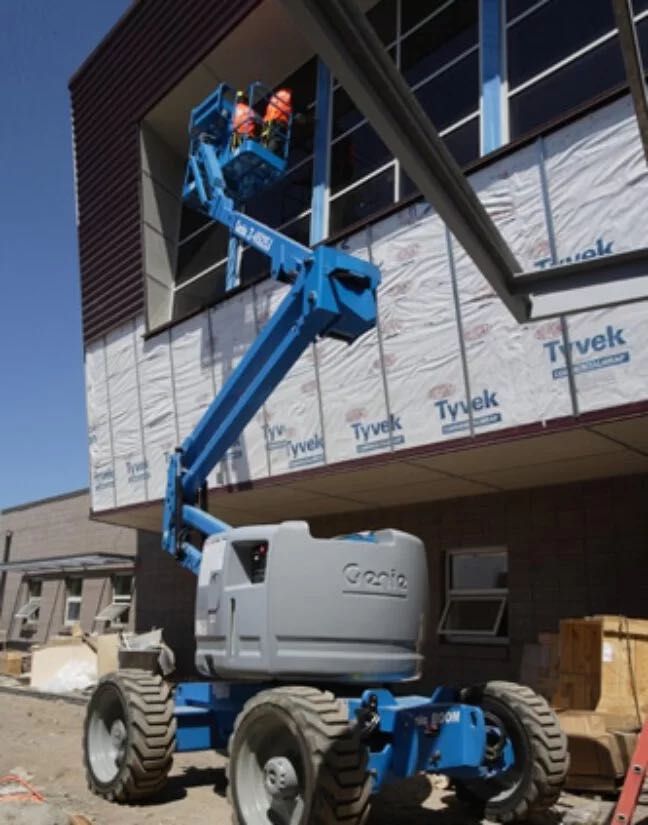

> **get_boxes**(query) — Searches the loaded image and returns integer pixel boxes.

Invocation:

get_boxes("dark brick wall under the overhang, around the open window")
[311,476,648,686]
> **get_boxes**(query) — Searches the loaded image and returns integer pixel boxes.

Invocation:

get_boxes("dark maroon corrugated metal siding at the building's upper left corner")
[70,0,260,342]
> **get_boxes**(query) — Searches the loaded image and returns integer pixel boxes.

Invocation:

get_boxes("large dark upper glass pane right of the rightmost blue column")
[508,0,615,89]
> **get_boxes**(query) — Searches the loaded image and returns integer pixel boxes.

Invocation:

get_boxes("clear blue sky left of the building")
[0,0,130,509]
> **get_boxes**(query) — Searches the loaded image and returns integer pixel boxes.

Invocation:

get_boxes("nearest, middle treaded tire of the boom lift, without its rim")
[227,686,371,825]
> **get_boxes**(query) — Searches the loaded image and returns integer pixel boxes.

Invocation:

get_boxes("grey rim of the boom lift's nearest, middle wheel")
[233,709,306,825]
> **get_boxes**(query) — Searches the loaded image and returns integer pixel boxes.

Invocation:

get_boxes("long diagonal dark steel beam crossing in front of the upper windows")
[282,0,528,321]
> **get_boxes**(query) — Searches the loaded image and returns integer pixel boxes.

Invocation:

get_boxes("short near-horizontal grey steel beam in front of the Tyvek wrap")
[513,249,648,321]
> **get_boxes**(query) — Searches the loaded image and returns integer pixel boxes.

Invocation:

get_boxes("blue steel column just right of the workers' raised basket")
[310,60,332,246]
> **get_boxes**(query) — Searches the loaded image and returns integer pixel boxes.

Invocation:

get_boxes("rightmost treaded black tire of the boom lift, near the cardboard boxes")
[454,682,569,822]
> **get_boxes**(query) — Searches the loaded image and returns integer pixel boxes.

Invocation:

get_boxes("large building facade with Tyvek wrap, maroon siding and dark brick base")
[70,0,648,678]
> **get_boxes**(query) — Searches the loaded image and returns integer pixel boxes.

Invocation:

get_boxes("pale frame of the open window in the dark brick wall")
[437,545,510,645]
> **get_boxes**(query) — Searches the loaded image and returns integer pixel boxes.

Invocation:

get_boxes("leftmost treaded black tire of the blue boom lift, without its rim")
[83,669,176,802]
